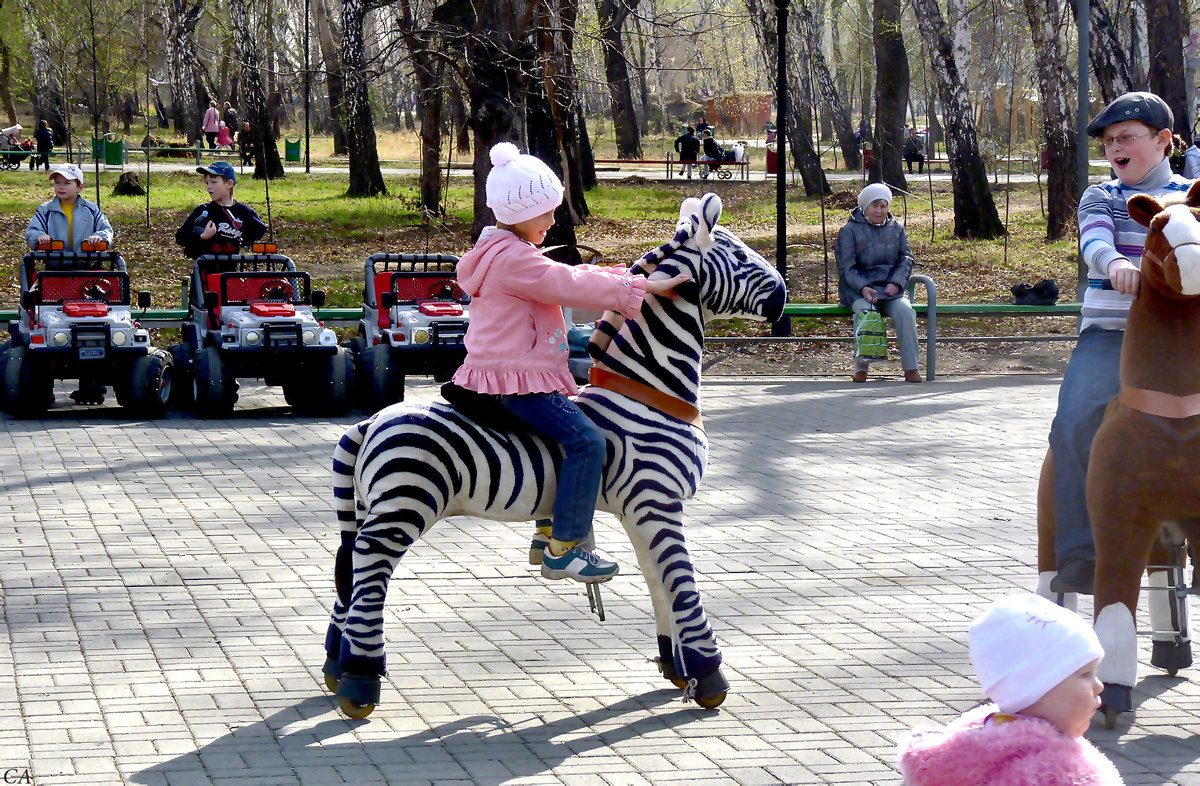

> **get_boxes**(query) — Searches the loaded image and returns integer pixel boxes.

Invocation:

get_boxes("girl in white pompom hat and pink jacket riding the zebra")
[448,142,688,583]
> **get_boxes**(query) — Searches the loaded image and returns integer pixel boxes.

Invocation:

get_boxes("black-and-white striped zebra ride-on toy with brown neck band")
[324,194,787,718]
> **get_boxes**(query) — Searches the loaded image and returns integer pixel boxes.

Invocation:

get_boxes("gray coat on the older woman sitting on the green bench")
[834,208,913,306]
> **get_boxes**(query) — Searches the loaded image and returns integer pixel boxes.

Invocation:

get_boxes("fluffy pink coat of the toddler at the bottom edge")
[899,704,1124,786]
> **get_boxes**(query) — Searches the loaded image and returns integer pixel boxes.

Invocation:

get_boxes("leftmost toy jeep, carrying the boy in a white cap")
[4,241,173,418]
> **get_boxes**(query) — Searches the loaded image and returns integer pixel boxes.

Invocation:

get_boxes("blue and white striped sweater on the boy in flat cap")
[1079,158,1192,331]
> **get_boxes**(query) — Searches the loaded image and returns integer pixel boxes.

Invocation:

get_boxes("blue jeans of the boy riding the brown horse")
[1050,328,1124,566]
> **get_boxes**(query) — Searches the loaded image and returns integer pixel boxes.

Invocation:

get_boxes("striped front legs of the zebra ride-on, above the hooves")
[622,502,721,680]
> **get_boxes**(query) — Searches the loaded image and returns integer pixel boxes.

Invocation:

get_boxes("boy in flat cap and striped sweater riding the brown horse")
[1038,92,1192,600]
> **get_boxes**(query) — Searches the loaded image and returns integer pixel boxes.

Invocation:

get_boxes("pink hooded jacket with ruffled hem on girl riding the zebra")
[454,227,646,395]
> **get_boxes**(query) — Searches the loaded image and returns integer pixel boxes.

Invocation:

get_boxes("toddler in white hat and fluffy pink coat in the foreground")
[899,593,1123,786]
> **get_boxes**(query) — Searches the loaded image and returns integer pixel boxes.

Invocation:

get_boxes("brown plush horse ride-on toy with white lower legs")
[1038,184,1200,728]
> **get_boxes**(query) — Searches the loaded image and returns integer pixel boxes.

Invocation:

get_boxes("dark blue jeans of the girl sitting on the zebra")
[496,392,605,541]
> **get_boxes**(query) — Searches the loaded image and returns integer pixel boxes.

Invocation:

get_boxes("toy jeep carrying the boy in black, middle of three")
[170,244,353,418]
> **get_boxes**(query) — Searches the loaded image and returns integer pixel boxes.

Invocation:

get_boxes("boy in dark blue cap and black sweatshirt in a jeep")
[175,161,266,259]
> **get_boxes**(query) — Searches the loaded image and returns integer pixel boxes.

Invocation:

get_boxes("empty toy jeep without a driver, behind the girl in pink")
[348,253,470,412]
